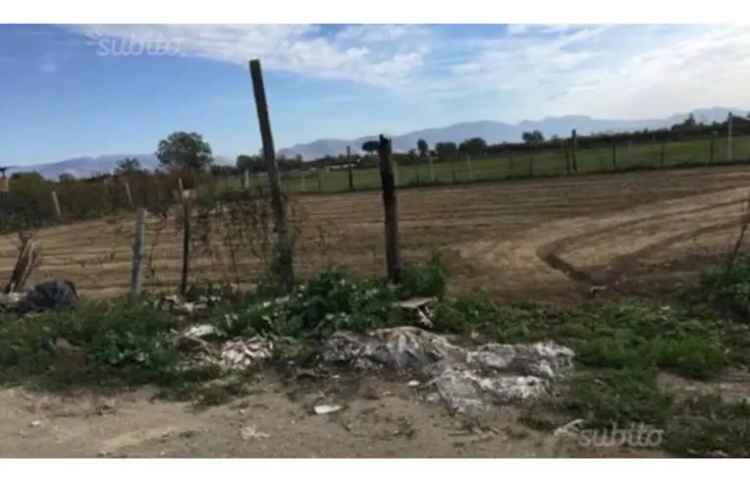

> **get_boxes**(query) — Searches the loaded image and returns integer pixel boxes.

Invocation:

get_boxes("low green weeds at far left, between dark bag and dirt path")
[0,300,188,383]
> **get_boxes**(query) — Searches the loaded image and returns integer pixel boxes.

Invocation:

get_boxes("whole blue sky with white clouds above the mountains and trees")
[0,24,750,165]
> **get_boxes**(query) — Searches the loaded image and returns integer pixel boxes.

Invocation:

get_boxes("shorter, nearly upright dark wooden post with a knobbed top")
[378,135,401,283]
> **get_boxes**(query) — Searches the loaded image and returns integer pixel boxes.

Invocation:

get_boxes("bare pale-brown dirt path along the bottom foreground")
[0,376,658,457]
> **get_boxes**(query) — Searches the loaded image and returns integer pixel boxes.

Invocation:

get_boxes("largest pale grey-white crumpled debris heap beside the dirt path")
[321,326,574,414]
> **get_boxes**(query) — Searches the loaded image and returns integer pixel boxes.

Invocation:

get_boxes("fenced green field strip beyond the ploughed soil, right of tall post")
[248,135,750,193]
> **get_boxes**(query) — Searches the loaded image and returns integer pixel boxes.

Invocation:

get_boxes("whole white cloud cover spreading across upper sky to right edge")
[63,24,750,120]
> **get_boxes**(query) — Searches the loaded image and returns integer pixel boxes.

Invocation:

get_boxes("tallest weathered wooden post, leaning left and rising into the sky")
[250,59,294,291]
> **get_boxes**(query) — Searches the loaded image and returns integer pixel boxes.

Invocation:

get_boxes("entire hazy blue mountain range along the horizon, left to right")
[8,107,748,179]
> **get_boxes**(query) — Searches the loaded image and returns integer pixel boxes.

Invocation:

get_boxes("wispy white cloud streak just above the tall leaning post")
[70,25,426,86]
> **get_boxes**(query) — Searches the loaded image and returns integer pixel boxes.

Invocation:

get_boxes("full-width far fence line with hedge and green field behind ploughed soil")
[0,133,750,233]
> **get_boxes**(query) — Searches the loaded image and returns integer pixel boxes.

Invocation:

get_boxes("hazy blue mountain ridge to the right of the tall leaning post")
[279,107,748,160]
